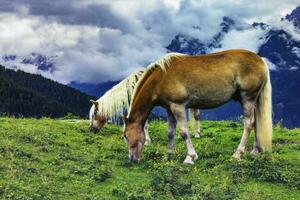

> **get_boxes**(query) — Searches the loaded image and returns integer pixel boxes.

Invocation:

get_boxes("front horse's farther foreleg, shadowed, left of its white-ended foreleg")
[167,110,176,158]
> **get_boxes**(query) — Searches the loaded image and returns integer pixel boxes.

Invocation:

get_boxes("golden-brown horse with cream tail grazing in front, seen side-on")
[123,50,272,164]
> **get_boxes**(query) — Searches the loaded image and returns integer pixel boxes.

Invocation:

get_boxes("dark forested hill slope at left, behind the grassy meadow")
[0,66,93,118]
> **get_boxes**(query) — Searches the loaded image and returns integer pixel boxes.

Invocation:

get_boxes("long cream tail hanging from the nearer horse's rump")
[255,60,272,151]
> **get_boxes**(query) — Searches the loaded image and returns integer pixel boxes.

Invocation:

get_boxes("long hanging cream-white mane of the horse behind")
[97,71,143,121]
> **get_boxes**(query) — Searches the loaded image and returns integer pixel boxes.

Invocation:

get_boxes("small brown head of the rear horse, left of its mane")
[90,100,106,133]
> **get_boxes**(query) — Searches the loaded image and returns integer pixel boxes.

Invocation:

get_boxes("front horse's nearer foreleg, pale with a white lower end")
[170,104,198,164]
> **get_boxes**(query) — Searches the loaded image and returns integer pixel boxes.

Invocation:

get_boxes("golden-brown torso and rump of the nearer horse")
[157,50,266,108]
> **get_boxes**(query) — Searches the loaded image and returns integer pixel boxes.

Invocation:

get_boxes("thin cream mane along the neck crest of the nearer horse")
[128,53,185,116]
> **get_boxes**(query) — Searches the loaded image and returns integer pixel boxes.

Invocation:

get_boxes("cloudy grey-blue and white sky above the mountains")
[0,0,300,84]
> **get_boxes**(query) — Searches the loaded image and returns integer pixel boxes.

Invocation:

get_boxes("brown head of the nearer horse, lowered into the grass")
[122,116,146,162]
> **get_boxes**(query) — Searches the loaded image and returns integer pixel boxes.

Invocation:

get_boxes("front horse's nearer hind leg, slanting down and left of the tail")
[233,101,255,158]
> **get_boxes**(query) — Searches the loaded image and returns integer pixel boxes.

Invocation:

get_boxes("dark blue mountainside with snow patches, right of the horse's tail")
[258,27,300,126]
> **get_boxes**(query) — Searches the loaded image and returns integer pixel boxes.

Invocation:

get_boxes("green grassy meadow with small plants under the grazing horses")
[0,118,300,200]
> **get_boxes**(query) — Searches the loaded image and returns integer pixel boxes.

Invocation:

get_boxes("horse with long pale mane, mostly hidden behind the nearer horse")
[89,70,200,143]
